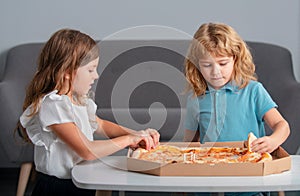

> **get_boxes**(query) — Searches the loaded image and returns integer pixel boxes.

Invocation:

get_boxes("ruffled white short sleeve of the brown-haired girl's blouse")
[39,93,75,130]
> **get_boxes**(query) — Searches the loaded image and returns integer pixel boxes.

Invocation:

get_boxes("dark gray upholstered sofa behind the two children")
[0,40,300,193]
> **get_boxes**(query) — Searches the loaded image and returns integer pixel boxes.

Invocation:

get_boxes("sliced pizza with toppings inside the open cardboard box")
[131,133,272,164]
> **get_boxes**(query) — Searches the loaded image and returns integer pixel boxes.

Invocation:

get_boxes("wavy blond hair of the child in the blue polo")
[185,23,256,96]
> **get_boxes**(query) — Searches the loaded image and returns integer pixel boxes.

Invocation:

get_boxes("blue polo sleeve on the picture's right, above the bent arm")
[255,83,278,120]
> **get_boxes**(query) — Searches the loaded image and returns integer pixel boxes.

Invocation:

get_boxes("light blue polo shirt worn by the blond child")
[185,81,277,143]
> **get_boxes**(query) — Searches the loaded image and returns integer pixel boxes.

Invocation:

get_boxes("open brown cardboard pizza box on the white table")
[127,141,291,176]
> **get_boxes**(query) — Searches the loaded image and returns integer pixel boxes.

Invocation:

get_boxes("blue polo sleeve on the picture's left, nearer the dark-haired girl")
[184,94,200,131]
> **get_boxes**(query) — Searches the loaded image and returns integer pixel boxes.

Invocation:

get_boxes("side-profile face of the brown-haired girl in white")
[72,58,99,95]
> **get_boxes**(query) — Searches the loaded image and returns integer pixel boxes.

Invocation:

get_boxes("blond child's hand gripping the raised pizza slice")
[251,136,279,153]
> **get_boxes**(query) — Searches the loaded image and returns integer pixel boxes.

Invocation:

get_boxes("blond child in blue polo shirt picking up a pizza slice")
[184,23,290,195]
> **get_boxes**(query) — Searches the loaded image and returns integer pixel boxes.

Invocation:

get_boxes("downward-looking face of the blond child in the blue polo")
[199,56,234,90]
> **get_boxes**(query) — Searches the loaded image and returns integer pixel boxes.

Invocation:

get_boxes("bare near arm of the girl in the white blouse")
[49,123,154,160]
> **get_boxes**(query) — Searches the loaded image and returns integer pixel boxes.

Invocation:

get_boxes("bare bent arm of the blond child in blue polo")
[252,108,290,153]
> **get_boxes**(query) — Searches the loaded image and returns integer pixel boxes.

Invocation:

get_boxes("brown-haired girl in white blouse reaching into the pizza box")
[20,29,159,195]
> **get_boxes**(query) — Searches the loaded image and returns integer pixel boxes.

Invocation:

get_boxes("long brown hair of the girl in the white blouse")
[17,29,99,140]
